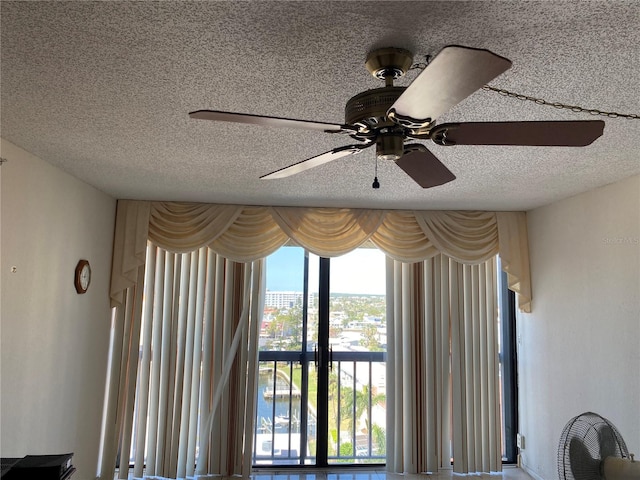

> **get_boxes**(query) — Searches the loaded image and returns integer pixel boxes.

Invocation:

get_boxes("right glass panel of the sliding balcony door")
[320,249,387,464]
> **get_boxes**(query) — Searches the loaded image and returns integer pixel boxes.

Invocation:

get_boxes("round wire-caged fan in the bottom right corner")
[558,412,640,480]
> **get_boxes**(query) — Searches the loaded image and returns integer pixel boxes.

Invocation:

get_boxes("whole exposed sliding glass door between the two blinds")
[254,247,386,466]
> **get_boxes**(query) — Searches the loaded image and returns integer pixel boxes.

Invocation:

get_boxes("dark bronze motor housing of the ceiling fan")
[344,87,406,131]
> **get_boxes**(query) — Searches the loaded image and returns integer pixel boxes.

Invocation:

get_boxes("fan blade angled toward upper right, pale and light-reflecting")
[387,45,511,127]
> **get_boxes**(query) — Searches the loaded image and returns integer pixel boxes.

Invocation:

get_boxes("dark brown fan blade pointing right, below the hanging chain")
[431,120,604,147]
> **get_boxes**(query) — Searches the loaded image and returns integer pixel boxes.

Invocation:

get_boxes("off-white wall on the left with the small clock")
[0,140,116,480]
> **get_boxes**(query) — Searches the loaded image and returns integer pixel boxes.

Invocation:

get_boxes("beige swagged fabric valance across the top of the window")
[111,200,531,312]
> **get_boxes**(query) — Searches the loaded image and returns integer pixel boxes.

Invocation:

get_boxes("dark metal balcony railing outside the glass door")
[253,352,386,466]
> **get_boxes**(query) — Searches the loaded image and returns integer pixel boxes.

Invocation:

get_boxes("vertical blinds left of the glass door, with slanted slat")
[103,244,264,478]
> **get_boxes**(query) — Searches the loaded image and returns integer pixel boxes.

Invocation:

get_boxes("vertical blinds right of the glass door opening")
[387,255,502,473]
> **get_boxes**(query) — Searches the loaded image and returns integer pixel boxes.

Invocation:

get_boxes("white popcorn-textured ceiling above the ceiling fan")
[0,0,640,210]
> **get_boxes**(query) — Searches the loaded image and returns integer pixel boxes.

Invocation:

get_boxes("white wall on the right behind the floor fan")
[517,176,640,480]
